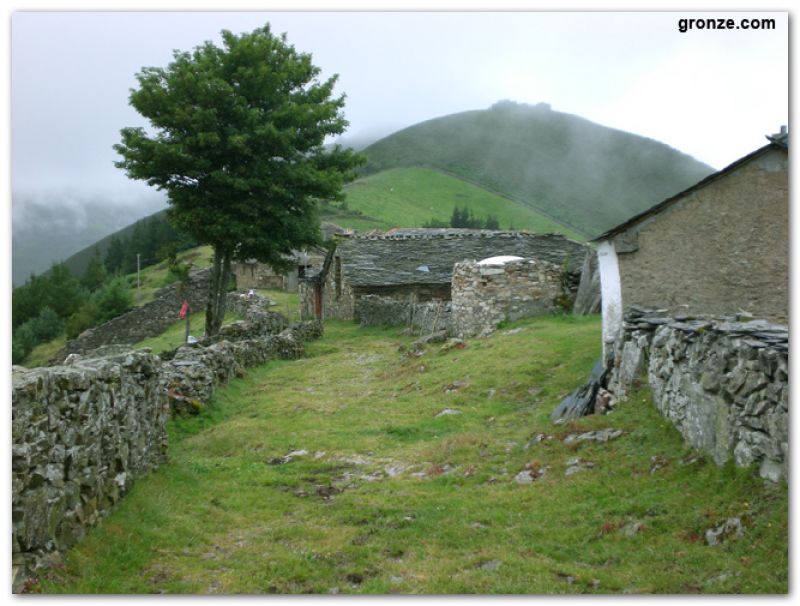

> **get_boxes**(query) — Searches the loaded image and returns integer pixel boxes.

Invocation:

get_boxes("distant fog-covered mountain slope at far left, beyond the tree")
[11,193,166,286]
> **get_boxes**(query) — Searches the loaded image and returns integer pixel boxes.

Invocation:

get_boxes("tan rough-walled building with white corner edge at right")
[594,127,789,356]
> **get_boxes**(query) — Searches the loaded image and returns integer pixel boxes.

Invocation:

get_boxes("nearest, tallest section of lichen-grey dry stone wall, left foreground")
[11,351,169,584]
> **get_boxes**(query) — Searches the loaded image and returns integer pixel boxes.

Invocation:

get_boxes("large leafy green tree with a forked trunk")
[114,25,361,335]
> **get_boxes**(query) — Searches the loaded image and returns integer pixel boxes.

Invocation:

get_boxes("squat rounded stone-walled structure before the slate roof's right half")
[452,259,563,338]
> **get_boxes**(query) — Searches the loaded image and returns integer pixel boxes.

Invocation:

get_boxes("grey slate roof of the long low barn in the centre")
[337,229,588,287]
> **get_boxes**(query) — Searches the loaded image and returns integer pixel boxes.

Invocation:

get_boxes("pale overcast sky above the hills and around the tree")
[11,12,789,207]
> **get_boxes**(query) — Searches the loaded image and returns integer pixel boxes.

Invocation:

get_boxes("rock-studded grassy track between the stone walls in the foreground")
[34,317,788,594]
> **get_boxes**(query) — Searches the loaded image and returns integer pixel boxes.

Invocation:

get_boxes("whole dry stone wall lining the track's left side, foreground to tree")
[12,298,322,591]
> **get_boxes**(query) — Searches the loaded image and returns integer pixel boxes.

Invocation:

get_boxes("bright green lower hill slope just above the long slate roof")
[322,168,582,239]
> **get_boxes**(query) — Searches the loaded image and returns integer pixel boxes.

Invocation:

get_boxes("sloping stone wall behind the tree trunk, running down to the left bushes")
[51,269,211,364]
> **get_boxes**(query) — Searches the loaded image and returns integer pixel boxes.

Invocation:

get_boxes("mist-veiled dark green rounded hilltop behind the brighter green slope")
[363,101,713,235]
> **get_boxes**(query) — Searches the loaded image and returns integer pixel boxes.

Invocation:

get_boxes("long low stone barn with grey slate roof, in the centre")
[300,229,589,320]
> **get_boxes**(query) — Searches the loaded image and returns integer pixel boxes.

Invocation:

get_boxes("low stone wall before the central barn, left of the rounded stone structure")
[355,295,452,334]
